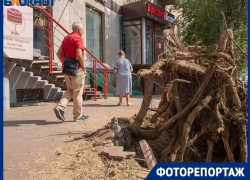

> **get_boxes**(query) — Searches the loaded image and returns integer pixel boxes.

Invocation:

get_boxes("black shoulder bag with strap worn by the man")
[62,47,79,76]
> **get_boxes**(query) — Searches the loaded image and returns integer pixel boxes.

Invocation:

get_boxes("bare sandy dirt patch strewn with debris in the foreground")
[28,134,149,180]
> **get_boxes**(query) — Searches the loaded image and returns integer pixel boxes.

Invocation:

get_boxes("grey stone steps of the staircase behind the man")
[8,58,103,101]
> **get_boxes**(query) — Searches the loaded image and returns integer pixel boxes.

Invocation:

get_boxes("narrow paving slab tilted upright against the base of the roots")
[140,140,157,170]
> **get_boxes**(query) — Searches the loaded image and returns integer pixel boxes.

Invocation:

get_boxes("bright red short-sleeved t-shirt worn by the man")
[61,32,84,69]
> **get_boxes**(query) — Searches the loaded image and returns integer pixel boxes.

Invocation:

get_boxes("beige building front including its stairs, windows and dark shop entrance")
[5,0,175,108]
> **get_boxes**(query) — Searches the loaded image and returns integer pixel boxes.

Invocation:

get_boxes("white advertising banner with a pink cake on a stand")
[3,6,33,60]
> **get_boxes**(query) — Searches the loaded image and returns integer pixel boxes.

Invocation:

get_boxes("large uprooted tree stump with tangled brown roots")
[130,13,248,162]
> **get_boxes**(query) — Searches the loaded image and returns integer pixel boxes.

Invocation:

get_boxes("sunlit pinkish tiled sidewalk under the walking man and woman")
[4,96,160,180]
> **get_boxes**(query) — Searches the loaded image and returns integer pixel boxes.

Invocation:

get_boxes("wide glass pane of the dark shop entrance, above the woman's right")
[123,18,141,64]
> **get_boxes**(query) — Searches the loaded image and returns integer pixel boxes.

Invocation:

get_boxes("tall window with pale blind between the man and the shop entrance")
[86,7,102,61]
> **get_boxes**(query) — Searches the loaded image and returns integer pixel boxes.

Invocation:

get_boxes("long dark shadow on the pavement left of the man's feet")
[3,120,65,127]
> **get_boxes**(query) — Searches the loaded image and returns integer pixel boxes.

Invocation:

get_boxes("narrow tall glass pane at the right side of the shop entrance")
[146,21,153,65]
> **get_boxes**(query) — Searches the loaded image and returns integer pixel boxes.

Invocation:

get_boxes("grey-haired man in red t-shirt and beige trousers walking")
[54,22,89,121]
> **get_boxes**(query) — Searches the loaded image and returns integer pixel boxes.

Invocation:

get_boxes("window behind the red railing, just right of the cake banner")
[33,9,49,56]
